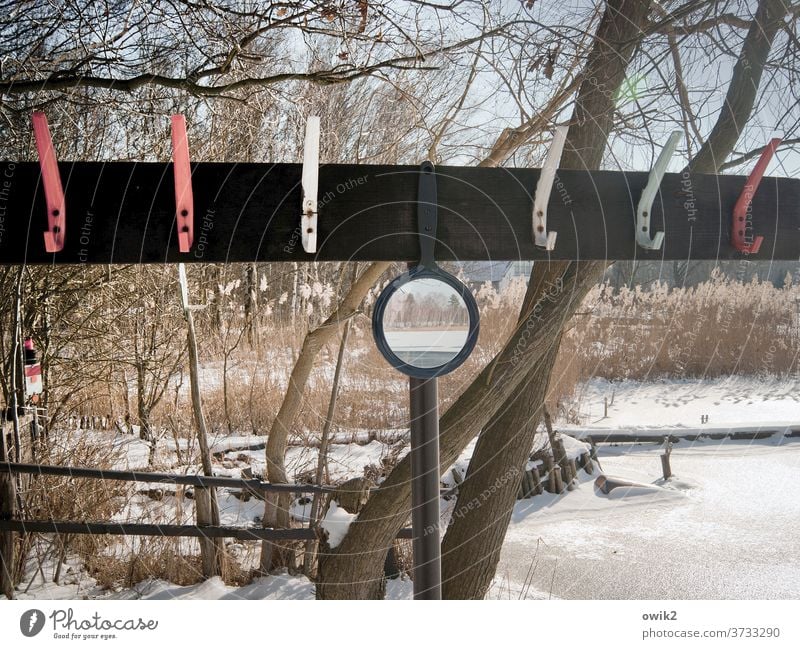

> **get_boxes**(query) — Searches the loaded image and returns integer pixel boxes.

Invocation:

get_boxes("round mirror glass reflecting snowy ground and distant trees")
[383,277,469,368]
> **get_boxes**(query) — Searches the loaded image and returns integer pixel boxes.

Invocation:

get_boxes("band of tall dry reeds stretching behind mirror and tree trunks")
[53,275,800,442]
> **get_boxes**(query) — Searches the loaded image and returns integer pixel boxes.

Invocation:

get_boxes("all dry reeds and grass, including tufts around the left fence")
[25,275,800,586]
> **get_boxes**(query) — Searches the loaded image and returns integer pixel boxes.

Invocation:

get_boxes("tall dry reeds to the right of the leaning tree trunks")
[551,274,800,412]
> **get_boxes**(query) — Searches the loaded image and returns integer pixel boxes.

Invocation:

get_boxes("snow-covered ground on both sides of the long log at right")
[490,377,800,599]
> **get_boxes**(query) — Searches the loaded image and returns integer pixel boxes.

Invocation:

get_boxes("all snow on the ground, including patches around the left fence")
[3,378,800,599]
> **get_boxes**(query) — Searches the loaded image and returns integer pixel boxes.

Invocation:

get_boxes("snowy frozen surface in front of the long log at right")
[498,436,800,599]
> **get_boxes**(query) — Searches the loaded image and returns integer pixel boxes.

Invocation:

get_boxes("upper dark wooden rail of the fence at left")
[0,462,337,493]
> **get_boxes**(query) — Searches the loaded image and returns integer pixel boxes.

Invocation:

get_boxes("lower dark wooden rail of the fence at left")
[0,519,411,541]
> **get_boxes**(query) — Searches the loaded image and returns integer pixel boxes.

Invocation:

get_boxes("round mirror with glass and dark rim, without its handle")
[372,266,478,378]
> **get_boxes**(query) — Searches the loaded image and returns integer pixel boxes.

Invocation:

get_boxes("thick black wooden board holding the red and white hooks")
[0,162,800,264]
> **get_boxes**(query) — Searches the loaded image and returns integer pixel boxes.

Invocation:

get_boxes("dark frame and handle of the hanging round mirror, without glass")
[372,162,480,379]
